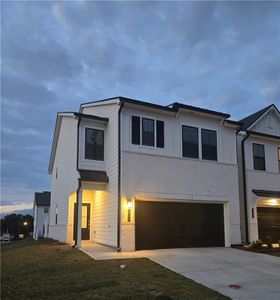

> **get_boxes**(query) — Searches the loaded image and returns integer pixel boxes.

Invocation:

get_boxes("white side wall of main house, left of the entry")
[49,116,79,242]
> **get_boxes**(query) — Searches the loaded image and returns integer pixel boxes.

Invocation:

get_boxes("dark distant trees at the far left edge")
[1,214,33,239]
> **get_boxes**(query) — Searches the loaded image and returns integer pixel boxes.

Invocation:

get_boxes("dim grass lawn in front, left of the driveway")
[1,240,229,300]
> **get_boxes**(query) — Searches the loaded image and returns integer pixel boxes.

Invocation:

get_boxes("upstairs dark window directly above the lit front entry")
[85,128,104,160]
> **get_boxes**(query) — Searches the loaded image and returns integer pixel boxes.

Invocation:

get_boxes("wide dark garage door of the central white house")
[135,201,225,250]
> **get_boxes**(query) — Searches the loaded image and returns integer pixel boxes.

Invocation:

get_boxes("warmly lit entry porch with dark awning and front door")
[67,170,110,247]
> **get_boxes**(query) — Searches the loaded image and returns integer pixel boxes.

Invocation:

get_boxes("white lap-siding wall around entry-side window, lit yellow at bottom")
[80,103,119,247]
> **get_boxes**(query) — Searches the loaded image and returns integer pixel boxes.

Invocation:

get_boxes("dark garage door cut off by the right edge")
[257,207,280,243]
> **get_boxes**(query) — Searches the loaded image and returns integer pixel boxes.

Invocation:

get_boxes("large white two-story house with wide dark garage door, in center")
[49,97,241,251]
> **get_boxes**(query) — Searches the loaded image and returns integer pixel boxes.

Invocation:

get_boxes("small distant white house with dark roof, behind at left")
[33,191,51,240]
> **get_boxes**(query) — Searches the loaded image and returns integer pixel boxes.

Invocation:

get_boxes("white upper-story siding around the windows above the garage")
[122,108,237,164]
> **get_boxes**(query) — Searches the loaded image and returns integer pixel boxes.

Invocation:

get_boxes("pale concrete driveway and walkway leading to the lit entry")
[80,244,280,300]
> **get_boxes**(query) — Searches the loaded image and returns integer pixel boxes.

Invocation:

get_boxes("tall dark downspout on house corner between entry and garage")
[117,101,124,252]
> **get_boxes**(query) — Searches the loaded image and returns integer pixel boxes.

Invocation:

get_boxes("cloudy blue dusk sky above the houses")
[1,1,280,212]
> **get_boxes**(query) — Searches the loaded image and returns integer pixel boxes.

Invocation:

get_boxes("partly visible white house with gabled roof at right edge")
[237,104,280,242]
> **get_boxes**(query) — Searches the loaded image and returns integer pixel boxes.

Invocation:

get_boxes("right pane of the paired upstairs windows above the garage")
[201,129,217,160]
